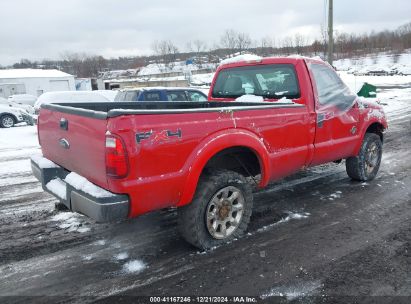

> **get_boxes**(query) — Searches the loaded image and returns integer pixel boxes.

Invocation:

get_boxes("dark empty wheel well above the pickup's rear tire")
[203,147,261,177]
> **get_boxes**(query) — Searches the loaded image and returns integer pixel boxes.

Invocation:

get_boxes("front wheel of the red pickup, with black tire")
[345,133,382,181]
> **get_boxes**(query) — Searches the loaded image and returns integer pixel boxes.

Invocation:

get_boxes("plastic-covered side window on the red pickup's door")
[310,63,356,109]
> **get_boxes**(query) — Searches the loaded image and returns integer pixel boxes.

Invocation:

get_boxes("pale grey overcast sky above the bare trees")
[0,0,411,65]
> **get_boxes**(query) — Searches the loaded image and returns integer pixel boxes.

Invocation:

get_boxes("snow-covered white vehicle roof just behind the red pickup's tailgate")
[34,91,111,112]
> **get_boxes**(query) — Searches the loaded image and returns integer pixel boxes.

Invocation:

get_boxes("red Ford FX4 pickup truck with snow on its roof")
[32,58,387,248]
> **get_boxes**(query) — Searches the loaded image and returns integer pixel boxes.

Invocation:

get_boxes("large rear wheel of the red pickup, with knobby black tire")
[178,169,253,250]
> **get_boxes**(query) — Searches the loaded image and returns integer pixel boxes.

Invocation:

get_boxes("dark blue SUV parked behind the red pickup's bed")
[115,88,207,101]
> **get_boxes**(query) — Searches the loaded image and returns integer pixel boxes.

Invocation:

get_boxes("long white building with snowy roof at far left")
[0,69,76,98]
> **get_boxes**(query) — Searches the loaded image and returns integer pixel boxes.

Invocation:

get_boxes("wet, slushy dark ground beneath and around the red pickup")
[0,88,411,303]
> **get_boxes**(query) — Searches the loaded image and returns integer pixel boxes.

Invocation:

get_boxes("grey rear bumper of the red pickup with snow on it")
[31,158,130,222]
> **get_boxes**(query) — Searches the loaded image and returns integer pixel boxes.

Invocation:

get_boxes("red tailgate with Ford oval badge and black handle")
[38,109,107,188]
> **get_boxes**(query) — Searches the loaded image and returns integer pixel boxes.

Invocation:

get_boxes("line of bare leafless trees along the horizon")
[6,22,411,77]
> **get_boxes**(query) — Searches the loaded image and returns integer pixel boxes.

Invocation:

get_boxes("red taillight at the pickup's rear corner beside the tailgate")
[106,135,128,178]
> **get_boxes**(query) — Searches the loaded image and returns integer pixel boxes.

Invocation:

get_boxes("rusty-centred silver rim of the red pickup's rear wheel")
[206,186,245,240]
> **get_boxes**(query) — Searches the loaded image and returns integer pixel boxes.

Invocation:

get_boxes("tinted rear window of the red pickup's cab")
[212,64,300,99]
